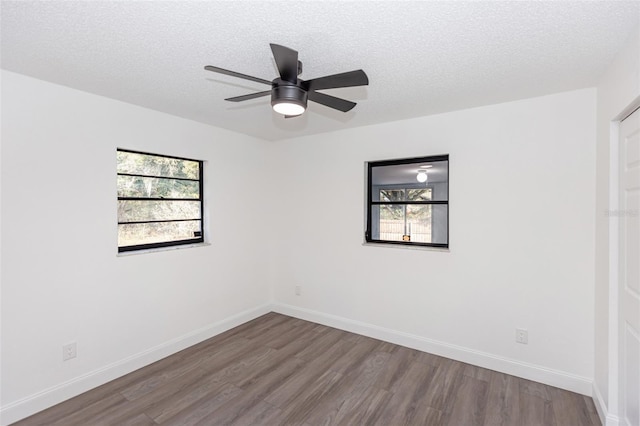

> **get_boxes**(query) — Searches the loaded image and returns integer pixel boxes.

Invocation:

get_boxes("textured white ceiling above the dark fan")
[0,0,640,140]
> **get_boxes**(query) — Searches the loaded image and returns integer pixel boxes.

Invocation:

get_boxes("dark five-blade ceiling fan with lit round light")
[204,43,369,118]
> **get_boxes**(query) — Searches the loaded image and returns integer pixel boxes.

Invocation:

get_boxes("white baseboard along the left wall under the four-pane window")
[0,304,271,426]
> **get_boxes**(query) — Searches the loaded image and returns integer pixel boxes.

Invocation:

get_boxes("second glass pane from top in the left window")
[118,176,200,199]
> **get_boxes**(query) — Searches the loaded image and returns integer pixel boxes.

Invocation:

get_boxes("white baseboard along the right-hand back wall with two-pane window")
[272,303,593,396]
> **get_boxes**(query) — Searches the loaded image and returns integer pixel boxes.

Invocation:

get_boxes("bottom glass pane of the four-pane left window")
[118,220,201,247]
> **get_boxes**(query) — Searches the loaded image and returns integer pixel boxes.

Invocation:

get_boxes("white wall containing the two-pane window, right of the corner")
[272,89,596,394]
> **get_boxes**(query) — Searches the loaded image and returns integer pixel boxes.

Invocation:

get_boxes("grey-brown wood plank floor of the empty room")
[16,313,600,426]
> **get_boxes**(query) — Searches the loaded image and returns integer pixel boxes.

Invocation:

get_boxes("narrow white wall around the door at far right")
[594,28,640,424]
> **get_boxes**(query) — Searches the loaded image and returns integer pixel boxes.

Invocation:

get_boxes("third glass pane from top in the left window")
[118,200,200,222]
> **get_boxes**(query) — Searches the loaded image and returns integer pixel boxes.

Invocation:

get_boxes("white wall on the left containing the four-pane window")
[2,71,270,423]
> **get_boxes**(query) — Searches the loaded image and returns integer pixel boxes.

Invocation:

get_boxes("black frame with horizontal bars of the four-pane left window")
[116,148,205,253]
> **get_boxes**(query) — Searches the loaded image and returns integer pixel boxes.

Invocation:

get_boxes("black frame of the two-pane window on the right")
[365,154,450,249]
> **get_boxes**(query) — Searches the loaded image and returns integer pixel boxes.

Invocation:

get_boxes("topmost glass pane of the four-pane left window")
[118,151,200,180]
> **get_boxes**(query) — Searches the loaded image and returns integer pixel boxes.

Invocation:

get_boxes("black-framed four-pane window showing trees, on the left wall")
[117,149,204,252]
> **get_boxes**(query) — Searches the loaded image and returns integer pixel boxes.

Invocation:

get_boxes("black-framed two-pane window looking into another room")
[365,155,449,248]
